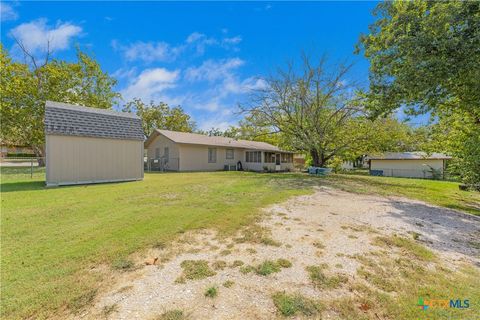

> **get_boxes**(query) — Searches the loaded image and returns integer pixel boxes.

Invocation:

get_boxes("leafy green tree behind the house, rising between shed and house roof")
[123,99,195,137]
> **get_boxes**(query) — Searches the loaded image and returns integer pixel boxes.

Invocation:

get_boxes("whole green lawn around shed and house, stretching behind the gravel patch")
[1,169,480,319]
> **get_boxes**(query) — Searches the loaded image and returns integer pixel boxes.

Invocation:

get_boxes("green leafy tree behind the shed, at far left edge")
[0,43,120,162]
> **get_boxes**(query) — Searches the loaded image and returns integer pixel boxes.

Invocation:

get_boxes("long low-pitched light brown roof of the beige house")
[145,129,285,152]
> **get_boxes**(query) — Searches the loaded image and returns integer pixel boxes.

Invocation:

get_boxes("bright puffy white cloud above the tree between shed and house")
[121,68,180,104]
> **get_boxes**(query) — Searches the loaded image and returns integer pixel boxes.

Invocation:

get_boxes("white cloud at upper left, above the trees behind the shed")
[10,19,82,53]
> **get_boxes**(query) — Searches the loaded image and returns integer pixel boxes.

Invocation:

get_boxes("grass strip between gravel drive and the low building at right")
[324,174,480,215]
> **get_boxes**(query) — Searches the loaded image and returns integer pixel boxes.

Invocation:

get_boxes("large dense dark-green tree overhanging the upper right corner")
[358,1,480,184]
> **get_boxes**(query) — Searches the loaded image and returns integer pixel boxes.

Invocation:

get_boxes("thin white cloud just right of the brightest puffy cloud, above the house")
[185,58,245,82]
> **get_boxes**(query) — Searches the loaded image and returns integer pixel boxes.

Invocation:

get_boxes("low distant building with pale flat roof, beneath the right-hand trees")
[368,152,451,178]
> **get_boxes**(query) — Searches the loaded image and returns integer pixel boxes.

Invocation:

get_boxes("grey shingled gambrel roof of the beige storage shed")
[45,101,144,140]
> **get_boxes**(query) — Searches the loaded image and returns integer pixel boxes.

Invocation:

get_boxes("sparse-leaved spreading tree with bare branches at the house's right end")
[241,55,373,166]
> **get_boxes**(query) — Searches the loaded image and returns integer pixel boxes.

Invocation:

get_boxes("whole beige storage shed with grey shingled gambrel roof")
[45,101,144,186]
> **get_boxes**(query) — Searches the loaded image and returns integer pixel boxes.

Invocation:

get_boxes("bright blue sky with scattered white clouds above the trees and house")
[1,1,386,130]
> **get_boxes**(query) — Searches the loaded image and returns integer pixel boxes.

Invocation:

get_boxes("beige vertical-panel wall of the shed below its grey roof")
[46,135,143,186]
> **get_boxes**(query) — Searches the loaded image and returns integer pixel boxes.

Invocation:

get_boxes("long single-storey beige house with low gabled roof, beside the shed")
[145,130,293,171]
